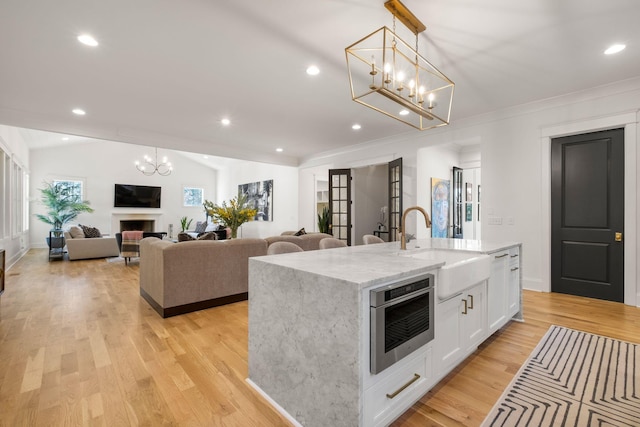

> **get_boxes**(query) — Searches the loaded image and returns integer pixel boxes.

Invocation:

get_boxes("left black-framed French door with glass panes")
[329,169,351,246]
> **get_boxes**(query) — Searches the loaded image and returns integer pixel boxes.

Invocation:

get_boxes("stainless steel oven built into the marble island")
[369,274,435,374]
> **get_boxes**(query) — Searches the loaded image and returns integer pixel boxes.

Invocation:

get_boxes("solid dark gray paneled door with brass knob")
[551,129,624,302]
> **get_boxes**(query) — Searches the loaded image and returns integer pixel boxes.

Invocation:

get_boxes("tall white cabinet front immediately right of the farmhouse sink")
[487,251,509,335]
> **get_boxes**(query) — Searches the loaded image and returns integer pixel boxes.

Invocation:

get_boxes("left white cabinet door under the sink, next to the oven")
[433,295,465,371]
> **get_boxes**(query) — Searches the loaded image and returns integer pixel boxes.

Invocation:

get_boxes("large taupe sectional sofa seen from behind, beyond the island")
[140,233,331,317]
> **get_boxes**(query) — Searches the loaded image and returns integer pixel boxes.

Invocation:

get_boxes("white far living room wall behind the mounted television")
[30,141,217,247]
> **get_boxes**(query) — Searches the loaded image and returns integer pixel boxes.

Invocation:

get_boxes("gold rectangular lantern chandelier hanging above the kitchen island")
[345,0,455,130]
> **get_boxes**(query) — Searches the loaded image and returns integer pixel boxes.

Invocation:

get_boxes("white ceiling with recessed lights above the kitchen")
[0,0,640,165]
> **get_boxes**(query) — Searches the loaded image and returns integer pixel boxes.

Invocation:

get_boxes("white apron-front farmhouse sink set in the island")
[398,249,491,299]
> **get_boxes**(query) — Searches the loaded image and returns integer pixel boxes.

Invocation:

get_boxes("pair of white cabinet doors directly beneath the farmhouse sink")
[433,281,487,372]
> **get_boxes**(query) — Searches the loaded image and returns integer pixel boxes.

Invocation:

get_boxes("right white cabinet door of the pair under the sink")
[461,281,487,353]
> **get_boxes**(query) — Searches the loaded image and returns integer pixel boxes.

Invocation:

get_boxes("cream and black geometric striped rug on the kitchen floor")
[482,326,640,427]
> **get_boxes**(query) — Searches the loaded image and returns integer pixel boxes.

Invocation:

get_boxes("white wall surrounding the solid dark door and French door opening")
[300,77,640,305]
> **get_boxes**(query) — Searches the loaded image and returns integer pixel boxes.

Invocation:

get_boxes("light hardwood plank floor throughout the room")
[0,250,640,427]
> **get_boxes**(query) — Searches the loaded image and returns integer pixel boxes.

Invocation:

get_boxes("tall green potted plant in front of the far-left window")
[36,182,93,248]
